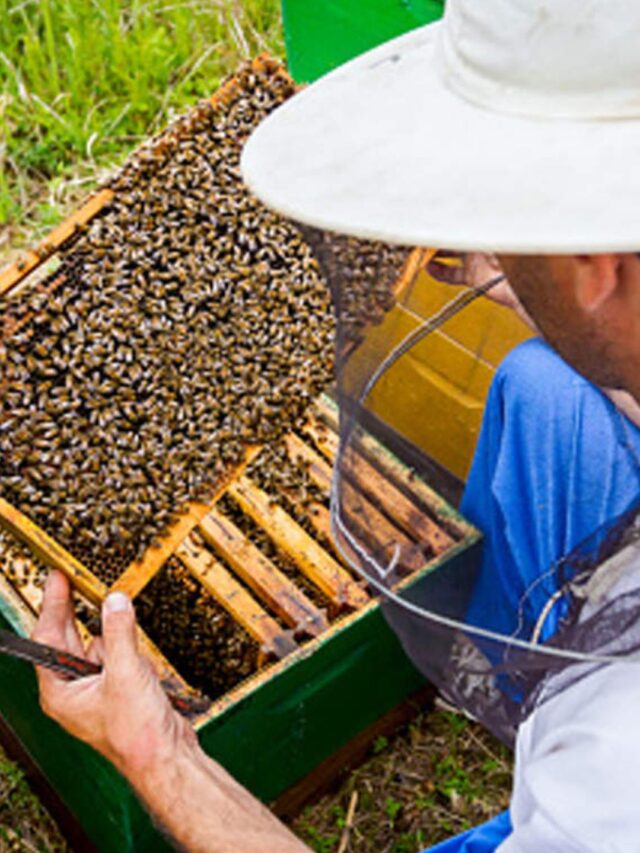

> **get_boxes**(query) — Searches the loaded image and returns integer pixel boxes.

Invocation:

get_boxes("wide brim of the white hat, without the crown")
[241,22,640,254]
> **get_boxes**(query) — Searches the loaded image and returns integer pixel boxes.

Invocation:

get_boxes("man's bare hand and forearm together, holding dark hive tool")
[33,572,309,853]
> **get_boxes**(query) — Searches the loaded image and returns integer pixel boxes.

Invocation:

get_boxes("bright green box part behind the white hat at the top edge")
[282,0,444,83]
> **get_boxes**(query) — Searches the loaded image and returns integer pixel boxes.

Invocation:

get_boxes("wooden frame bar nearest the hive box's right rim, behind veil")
[304,410,453,555]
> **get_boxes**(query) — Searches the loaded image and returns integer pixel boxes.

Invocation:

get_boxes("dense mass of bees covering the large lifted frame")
[0,63,334,581]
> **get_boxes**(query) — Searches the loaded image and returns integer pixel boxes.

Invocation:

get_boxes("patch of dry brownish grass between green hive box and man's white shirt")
[293,710,512,853]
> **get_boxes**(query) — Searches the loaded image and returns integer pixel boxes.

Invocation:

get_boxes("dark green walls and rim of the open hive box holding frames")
[0,440,480,853]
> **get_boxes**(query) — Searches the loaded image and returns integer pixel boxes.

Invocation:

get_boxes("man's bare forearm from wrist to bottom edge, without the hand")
[126,742,308,853]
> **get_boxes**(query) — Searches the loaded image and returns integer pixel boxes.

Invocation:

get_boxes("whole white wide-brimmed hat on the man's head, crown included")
[242,0,640,254]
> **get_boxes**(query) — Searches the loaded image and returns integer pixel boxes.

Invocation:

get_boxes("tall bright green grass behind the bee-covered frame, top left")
[0,0,283,242]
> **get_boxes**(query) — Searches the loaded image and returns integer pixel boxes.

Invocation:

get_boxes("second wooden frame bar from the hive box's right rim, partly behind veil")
[285,433,425,571]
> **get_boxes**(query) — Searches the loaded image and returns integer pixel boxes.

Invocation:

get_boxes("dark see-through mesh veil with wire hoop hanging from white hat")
[292,226,640,743]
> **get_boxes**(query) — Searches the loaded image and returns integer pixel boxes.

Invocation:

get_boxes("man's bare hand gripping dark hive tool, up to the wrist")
[33,572,195,781]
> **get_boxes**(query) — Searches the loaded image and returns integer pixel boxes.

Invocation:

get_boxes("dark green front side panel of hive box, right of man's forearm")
[199,592,424,801]
